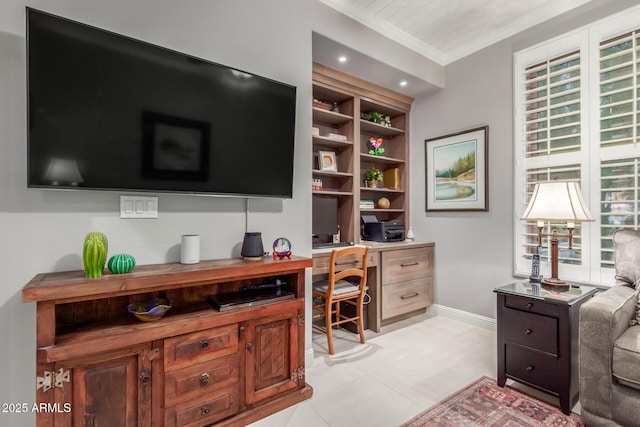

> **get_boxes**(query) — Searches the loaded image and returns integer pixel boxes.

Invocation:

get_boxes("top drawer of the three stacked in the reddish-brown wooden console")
[164,323,238,371]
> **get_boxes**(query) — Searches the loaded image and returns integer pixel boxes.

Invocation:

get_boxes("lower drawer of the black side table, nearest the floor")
[505,344,559,393]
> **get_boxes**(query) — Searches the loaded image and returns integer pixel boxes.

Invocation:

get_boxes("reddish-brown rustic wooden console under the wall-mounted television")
[22,257,313,426]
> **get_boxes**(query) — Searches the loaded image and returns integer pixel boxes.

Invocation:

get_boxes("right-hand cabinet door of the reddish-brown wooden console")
[243,310,304,405]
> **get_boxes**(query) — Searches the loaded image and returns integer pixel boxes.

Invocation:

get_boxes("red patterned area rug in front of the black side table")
[402,377,584,427]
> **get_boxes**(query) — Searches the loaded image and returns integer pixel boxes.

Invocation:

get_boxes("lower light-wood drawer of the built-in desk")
[382,277,433,319]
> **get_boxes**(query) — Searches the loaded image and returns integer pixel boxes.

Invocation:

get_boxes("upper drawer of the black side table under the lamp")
[503,308,558,355]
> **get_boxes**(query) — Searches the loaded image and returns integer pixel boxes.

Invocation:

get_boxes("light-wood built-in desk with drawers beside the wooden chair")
[312,241,435,332]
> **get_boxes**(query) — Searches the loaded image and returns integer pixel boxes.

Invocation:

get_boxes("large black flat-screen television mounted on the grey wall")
[27,8,296,198]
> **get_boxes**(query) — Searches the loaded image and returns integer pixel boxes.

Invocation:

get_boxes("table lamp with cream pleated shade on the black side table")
[521,181,593,288]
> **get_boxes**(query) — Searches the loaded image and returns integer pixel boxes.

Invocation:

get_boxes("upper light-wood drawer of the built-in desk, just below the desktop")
[382,247,433,284]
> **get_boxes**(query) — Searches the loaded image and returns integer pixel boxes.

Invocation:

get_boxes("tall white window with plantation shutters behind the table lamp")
[514,7,640,284]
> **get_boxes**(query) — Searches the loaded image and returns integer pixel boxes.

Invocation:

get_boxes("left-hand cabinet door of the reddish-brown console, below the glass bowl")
[57,345,154,427]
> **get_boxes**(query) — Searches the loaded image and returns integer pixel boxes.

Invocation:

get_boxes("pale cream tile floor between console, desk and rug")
[246,313,580,427]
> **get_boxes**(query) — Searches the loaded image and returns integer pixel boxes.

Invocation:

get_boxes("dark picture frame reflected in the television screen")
[142,112,211,181]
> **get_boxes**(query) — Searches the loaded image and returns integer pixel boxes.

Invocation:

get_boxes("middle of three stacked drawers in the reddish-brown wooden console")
[165,353,238,406]
